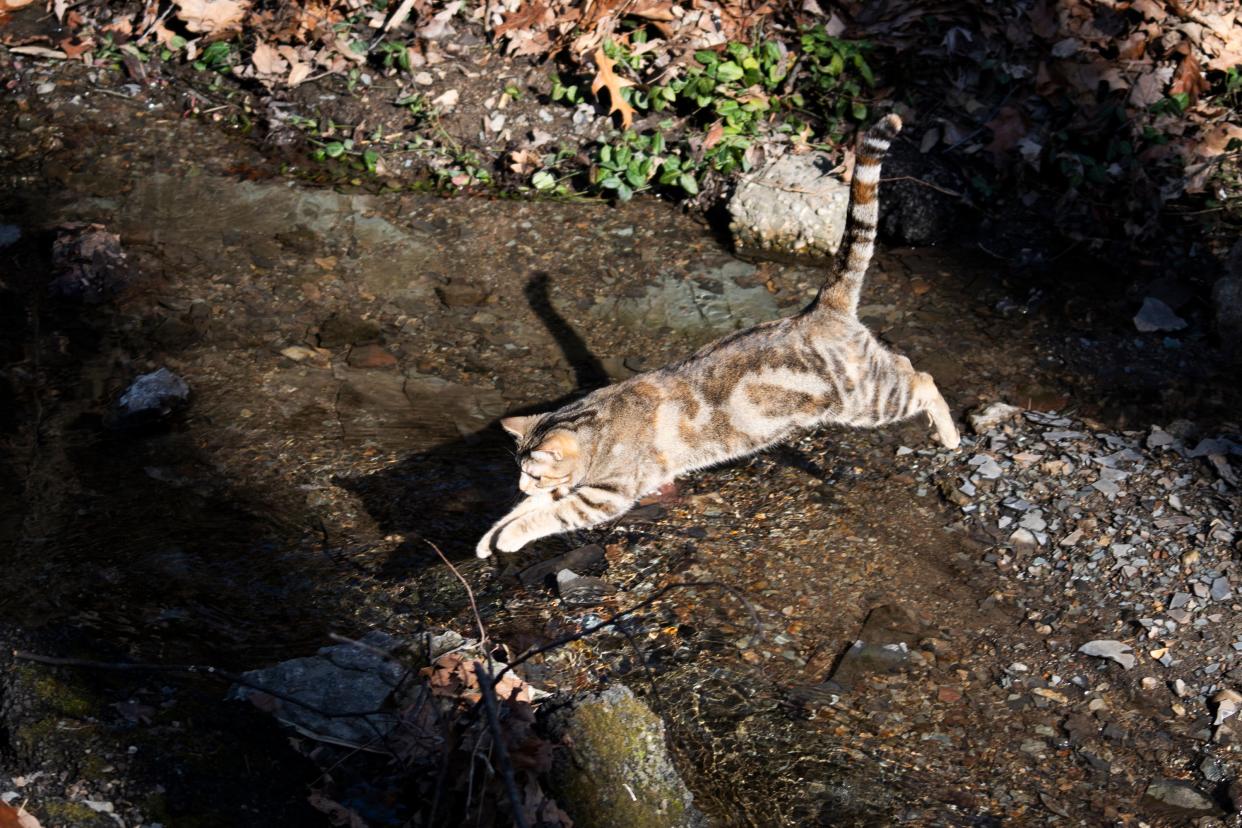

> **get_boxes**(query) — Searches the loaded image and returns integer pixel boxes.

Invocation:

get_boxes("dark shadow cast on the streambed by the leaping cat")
[333,273,827,580]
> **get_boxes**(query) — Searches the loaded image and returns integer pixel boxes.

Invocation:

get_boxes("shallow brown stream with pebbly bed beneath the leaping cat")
[0,32,1240,826]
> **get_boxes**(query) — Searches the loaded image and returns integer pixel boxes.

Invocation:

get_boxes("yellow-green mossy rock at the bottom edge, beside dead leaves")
[549,685,705,828]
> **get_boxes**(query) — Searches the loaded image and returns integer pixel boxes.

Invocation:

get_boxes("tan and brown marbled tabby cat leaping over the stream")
[476,115,959,557]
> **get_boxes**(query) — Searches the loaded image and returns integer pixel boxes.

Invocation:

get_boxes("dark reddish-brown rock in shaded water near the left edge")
[47,225,129,304]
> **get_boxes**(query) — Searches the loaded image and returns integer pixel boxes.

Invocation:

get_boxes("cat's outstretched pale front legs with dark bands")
[474,485,633,557]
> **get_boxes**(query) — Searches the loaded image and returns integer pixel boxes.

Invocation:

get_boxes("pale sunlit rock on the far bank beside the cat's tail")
[729,153,850,258]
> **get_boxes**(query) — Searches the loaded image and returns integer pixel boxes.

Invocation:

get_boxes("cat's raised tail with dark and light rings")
[812,115,902,314]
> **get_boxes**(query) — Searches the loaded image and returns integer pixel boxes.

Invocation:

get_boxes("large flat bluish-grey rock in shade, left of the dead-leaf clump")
[229,631,406,746]
